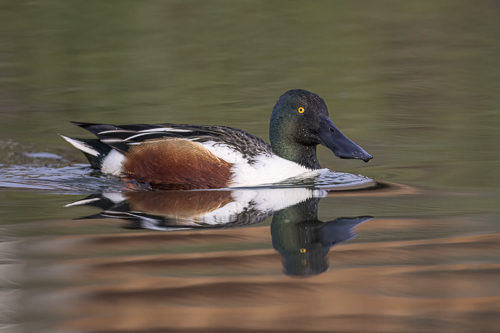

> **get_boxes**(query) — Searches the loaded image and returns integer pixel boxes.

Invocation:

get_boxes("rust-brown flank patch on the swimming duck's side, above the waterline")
[123,139,233,190]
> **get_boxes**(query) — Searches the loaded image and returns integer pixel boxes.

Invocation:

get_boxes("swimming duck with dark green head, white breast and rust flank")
[61,89,372,190]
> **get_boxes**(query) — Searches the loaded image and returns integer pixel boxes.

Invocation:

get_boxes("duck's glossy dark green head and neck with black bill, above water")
[269,89,372,169]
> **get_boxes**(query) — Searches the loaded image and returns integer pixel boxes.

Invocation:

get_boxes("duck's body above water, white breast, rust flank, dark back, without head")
[64,123,312,189]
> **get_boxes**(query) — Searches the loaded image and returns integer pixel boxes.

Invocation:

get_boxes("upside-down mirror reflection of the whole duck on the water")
[71,188,372,275]
